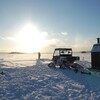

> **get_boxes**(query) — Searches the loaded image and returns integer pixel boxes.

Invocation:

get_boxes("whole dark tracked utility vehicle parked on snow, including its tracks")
[48,48,91,75]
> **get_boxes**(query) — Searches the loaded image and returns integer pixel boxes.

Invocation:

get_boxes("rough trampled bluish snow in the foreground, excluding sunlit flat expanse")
[0,59,100,100]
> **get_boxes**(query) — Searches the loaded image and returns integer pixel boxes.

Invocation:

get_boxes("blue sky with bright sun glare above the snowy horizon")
[0,0,100,52]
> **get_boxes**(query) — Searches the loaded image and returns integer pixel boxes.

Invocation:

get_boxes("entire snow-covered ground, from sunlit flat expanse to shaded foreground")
[0,54,100,100]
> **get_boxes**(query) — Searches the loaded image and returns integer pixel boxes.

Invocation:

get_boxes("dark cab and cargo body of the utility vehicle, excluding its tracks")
[52,48,80,64]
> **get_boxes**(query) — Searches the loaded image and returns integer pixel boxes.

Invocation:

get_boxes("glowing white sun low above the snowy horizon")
[16,23,45,52]
